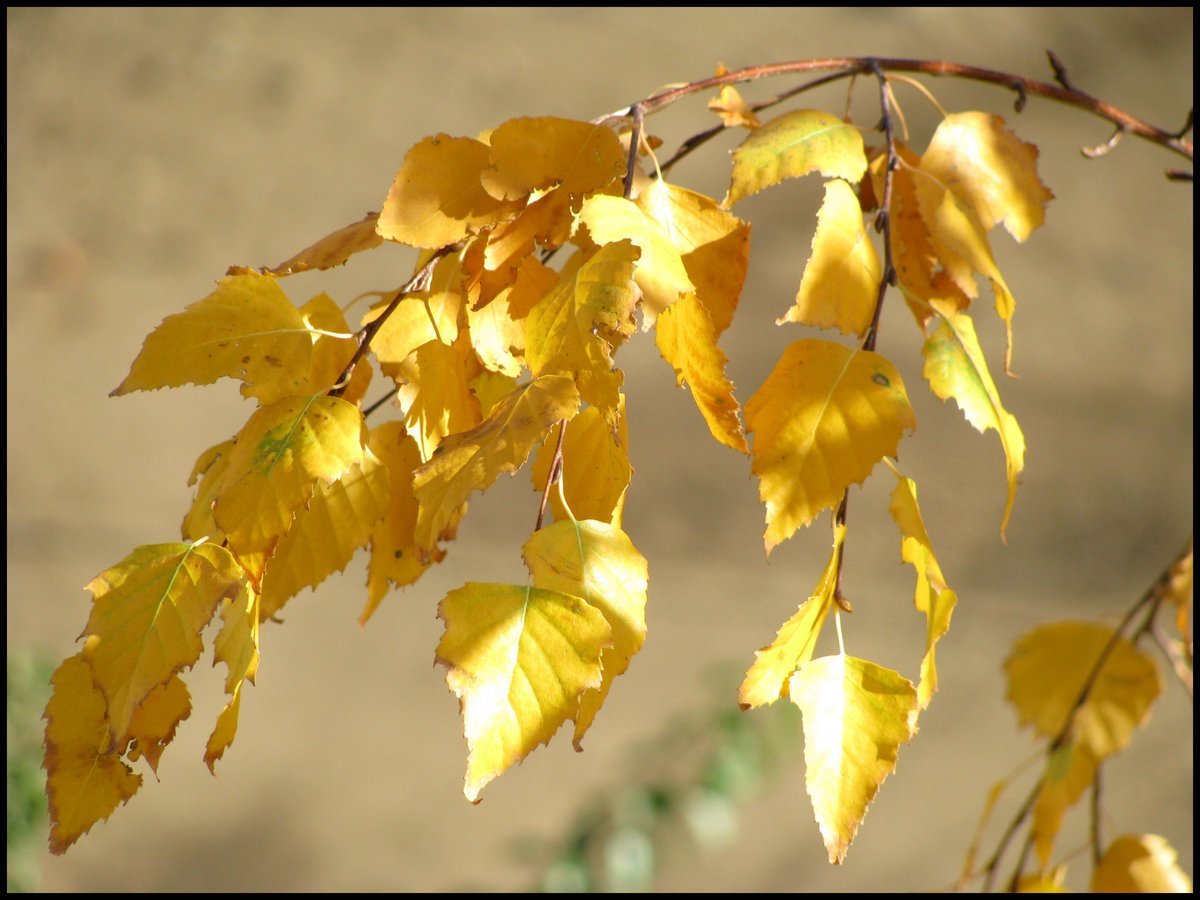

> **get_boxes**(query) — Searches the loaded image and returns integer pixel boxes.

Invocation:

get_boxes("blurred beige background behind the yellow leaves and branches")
[7,7,1193,892]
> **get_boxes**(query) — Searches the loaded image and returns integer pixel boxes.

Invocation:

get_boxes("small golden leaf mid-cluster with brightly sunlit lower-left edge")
[397,332,481,460]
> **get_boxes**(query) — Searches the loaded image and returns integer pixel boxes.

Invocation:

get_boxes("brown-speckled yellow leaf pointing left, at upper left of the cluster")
[110,272,312,404]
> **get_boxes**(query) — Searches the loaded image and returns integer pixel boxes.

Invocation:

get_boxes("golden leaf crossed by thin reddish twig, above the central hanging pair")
[530,395,634,527]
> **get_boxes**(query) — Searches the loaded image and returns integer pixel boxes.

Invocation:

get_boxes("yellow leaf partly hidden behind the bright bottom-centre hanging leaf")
[523,520,648,750]
